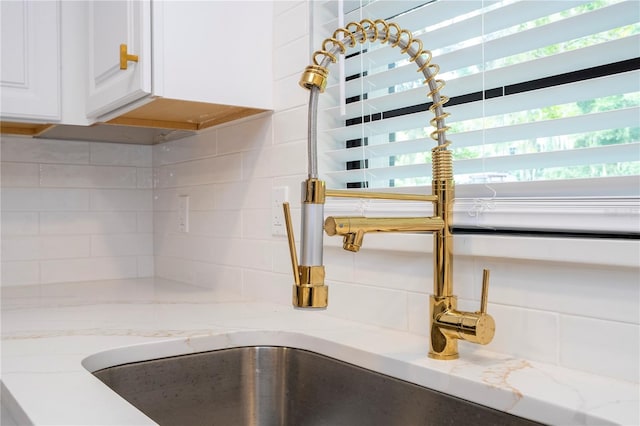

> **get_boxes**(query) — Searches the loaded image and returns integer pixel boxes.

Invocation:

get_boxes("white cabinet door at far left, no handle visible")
[0,0,60,122]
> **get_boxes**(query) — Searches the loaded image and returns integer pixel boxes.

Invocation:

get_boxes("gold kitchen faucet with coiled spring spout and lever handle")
[284,19,495,359]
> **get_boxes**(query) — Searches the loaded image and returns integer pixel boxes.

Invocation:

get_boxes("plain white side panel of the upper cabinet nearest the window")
[153,0,273,109]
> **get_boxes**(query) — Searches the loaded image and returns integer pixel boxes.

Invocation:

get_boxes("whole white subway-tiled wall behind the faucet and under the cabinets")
[2,2,640,382]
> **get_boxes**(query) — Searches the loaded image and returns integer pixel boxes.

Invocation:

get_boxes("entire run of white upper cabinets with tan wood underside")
[0,0,273,140]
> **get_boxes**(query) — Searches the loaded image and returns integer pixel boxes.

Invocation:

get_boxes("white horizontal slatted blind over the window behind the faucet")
[314,0,640,204]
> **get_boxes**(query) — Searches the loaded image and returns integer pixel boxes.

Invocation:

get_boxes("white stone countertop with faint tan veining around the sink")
[1,279,640,425]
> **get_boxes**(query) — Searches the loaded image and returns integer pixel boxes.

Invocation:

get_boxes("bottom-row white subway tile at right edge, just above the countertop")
[559,314,640,383]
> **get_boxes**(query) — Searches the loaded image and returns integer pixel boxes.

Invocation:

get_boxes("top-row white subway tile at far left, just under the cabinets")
[0,136,89,164]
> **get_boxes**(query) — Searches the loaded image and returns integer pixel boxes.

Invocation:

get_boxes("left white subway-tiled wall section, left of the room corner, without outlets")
[0,136,153,286]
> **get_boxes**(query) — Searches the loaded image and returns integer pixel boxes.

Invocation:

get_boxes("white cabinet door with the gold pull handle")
[87,0,151,118]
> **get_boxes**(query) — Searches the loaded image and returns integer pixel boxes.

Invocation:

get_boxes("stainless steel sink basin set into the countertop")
[93,346,538,426]
